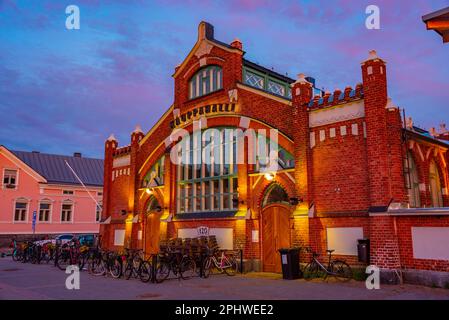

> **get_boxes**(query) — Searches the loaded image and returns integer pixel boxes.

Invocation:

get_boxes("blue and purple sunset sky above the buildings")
[0,0,449,157]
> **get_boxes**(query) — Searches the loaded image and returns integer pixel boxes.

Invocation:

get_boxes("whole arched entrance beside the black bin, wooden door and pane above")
[261,184,290,272]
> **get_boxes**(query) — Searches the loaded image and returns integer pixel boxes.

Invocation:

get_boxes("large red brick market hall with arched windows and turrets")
[100,22,449,275]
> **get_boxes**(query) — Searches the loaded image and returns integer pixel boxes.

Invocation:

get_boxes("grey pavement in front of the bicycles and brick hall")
[0,257,449,300]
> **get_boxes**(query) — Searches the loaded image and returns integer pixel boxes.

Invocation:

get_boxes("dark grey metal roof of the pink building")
[11,150,103,187]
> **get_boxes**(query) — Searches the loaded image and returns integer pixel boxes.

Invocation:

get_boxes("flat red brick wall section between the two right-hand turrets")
[310,118,370,213]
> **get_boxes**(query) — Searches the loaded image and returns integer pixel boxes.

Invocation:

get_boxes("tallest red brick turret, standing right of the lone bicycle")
[362,50,404,276]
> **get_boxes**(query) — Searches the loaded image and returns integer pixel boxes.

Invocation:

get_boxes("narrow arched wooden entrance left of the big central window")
[143,197,162,254]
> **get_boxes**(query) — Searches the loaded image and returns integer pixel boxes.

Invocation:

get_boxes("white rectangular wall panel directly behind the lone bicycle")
[327,227,363,256]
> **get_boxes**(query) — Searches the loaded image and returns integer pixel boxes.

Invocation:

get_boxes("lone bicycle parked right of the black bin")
[303,248,352,281]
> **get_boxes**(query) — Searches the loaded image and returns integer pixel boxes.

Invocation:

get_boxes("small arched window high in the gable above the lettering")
[189,66,223,99]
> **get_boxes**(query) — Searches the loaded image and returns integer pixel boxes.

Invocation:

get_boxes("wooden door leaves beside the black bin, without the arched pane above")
[262,204,290,272]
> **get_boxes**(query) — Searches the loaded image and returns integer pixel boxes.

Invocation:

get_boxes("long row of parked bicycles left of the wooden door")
[12,236,238,283]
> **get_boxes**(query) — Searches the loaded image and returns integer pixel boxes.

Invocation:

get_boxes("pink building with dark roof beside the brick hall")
[0,145,103,245]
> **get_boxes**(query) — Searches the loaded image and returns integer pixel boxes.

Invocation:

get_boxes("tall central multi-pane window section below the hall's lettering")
[177,128,238,214]
